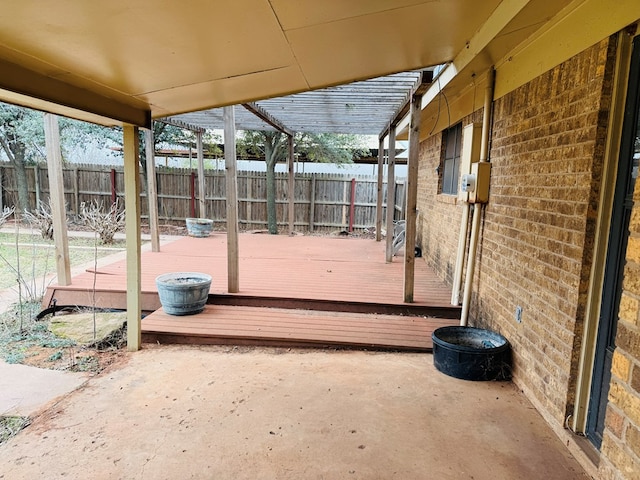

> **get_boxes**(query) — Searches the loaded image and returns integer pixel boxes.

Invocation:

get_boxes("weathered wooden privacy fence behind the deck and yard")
[0,163,405,232]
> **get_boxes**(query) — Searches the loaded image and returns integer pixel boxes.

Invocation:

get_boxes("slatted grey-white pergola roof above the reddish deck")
[165,71,421,135]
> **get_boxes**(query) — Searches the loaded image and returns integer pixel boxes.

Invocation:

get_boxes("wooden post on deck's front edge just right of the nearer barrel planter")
[223,106,240,293]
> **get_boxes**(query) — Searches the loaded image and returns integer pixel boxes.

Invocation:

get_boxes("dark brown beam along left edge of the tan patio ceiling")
[0,60,151,128]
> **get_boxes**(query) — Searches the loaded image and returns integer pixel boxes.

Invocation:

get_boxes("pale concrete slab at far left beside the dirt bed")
[0,360,89,417]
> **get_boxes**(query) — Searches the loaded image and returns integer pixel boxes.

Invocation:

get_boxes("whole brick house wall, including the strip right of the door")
[417,28,640,479]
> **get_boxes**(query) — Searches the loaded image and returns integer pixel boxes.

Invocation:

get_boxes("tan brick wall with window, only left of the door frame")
[418,34,616,446]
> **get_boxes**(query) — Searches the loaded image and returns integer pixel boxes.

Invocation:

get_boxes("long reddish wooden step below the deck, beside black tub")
[142,305,457,352]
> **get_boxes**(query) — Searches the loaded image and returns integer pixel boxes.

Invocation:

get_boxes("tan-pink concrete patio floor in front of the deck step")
[0,346,588,480]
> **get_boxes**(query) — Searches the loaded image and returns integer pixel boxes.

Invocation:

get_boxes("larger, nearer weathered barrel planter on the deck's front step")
[156,272,211,315]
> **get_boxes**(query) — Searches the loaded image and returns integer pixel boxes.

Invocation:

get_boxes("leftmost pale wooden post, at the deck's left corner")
[43,113,71,285]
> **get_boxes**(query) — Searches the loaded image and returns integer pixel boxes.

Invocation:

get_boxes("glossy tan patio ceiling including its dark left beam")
[0,0,589,126]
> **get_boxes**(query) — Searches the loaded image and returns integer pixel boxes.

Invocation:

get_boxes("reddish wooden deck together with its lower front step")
[44,233,459,351]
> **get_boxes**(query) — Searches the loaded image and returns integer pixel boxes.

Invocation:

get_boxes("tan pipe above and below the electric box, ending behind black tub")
[460,67,495,327]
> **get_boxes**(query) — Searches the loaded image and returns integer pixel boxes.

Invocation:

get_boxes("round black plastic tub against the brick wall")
[431,327,511,380]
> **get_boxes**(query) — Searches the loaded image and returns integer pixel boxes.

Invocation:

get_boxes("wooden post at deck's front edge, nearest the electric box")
[404,94,422,303]
